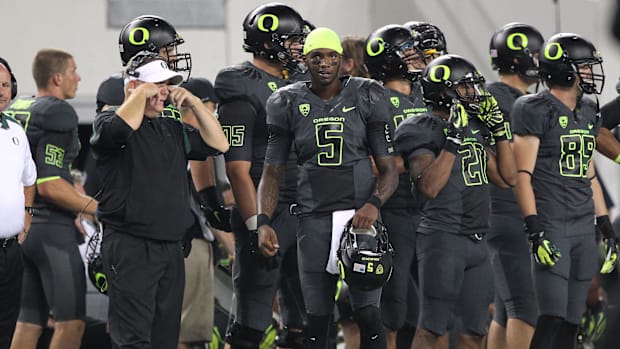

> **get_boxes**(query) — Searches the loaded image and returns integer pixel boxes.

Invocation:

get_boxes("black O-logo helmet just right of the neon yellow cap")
[364,24,421,81]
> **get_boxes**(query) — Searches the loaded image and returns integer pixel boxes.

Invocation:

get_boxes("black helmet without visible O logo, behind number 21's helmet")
[404,21,448,64]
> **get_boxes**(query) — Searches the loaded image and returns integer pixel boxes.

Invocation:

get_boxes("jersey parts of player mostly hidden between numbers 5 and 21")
[382,89,426,209]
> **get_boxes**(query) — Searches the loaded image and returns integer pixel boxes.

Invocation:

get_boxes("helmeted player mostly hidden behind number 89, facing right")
[487,23,544,349]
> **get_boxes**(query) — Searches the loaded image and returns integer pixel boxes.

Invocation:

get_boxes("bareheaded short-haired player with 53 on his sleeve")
[9,49,97,349]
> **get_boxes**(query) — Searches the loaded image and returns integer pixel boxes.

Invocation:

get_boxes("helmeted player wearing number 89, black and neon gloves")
[511,33,617,349]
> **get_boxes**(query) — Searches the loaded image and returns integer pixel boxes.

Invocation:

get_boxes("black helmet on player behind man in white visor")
[118,15,192,80]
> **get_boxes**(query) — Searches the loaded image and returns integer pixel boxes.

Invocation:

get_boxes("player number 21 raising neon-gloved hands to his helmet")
[395,55,516,349]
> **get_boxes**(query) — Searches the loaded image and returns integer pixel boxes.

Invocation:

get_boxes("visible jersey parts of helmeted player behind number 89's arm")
[487,81,523,215]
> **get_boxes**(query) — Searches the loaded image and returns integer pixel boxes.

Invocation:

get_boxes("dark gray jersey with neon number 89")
[511,91,600,235]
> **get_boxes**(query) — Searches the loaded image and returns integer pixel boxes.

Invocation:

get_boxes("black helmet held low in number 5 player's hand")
[338,220,394,291]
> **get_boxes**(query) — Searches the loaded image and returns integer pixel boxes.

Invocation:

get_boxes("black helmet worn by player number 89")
[538,33,605,94]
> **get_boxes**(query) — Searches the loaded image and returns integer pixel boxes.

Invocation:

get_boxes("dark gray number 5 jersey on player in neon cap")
[265,77,394,214]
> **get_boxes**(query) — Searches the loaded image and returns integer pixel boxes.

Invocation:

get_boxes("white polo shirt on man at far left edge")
[0,116,37,239]
